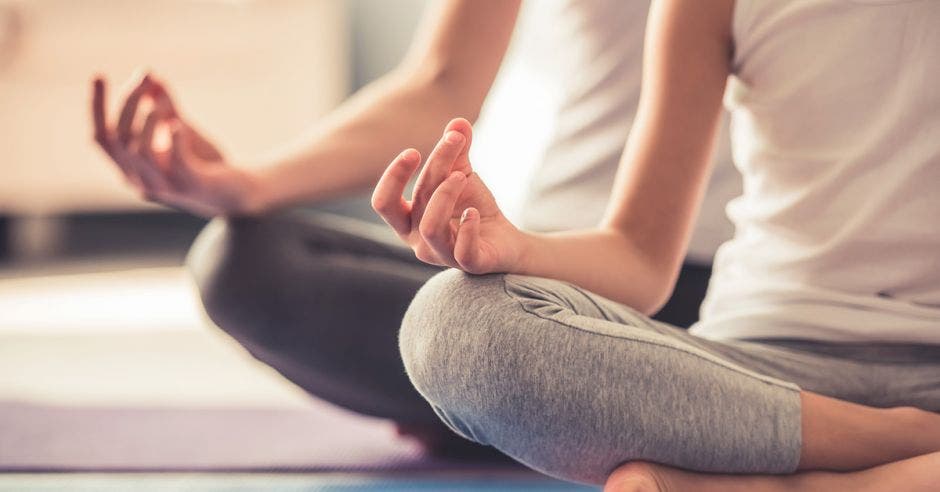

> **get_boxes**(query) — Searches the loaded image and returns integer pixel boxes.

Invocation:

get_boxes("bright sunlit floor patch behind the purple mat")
[0,267,309,408]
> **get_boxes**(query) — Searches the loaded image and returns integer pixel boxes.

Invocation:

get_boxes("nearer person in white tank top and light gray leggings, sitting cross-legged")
[372,0,940,491]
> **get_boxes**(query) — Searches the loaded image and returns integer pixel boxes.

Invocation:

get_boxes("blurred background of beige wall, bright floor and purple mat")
[0,0,576,488]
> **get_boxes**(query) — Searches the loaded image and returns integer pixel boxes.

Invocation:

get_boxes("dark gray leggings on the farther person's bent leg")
[187,212,707,432]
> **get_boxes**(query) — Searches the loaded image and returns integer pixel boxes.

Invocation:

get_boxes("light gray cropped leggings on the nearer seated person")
[400,270,940,483]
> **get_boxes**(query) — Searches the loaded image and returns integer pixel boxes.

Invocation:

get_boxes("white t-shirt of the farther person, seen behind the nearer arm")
[517,0,741,263]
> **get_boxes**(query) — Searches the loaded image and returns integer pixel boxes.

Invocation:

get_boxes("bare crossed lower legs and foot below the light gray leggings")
[604,392,940,492]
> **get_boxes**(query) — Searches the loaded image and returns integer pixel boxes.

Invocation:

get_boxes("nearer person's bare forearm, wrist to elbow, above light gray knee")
[510,229,676,314]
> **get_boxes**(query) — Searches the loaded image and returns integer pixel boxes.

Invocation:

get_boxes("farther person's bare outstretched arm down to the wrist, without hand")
[242,0,520,212]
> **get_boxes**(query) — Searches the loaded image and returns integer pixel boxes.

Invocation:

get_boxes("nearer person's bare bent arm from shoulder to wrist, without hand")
[506,0,733,314]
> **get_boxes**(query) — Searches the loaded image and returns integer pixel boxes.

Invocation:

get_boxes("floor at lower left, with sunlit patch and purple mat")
[0,259,593,491]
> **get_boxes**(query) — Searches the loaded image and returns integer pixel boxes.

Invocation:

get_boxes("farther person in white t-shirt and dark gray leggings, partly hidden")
[92,0,739,457]
